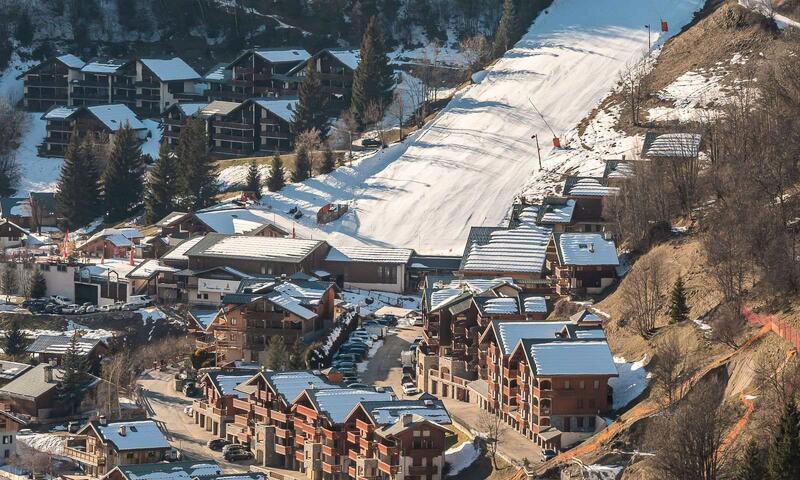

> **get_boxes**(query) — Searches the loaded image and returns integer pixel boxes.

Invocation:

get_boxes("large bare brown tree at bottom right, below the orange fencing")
[646,379,734,480]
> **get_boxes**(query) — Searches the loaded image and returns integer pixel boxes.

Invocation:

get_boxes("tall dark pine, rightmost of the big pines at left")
[176,117,219,210]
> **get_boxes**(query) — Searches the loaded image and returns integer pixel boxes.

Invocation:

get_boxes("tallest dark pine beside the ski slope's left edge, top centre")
[350,17,394,126]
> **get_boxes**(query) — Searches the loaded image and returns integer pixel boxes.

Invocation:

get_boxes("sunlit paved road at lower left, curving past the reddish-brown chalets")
[139,371,249,472]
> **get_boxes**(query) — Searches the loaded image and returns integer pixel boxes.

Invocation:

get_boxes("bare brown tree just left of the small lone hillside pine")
[622,255,665,338]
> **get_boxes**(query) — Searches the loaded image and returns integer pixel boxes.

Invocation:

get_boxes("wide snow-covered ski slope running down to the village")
[255,0,703,254]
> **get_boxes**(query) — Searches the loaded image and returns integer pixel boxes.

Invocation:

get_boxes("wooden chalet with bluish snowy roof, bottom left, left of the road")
[63,420,171,477]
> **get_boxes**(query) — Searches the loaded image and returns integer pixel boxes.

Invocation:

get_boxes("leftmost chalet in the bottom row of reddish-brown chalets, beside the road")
[192,369,255,438]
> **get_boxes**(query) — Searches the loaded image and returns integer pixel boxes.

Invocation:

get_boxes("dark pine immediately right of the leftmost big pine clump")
[103,124,145,222]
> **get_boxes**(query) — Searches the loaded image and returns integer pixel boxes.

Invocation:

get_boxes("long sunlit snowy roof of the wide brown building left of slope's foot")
[186,233,323,263]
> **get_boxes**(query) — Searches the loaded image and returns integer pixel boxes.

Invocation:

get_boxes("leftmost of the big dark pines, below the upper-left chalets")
[56,133,101,229]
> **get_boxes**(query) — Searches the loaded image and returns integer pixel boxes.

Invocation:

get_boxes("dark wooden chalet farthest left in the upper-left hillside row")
[20,54,85,112]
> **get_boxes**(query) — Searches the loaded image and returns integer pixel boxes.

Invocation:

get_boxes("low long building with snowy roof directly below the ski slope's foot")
[323,245,414,293]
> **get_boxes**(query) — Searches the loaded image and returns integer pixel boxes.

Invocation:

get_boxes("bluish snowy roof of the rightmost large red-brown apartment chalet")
[522,339,618,376]
